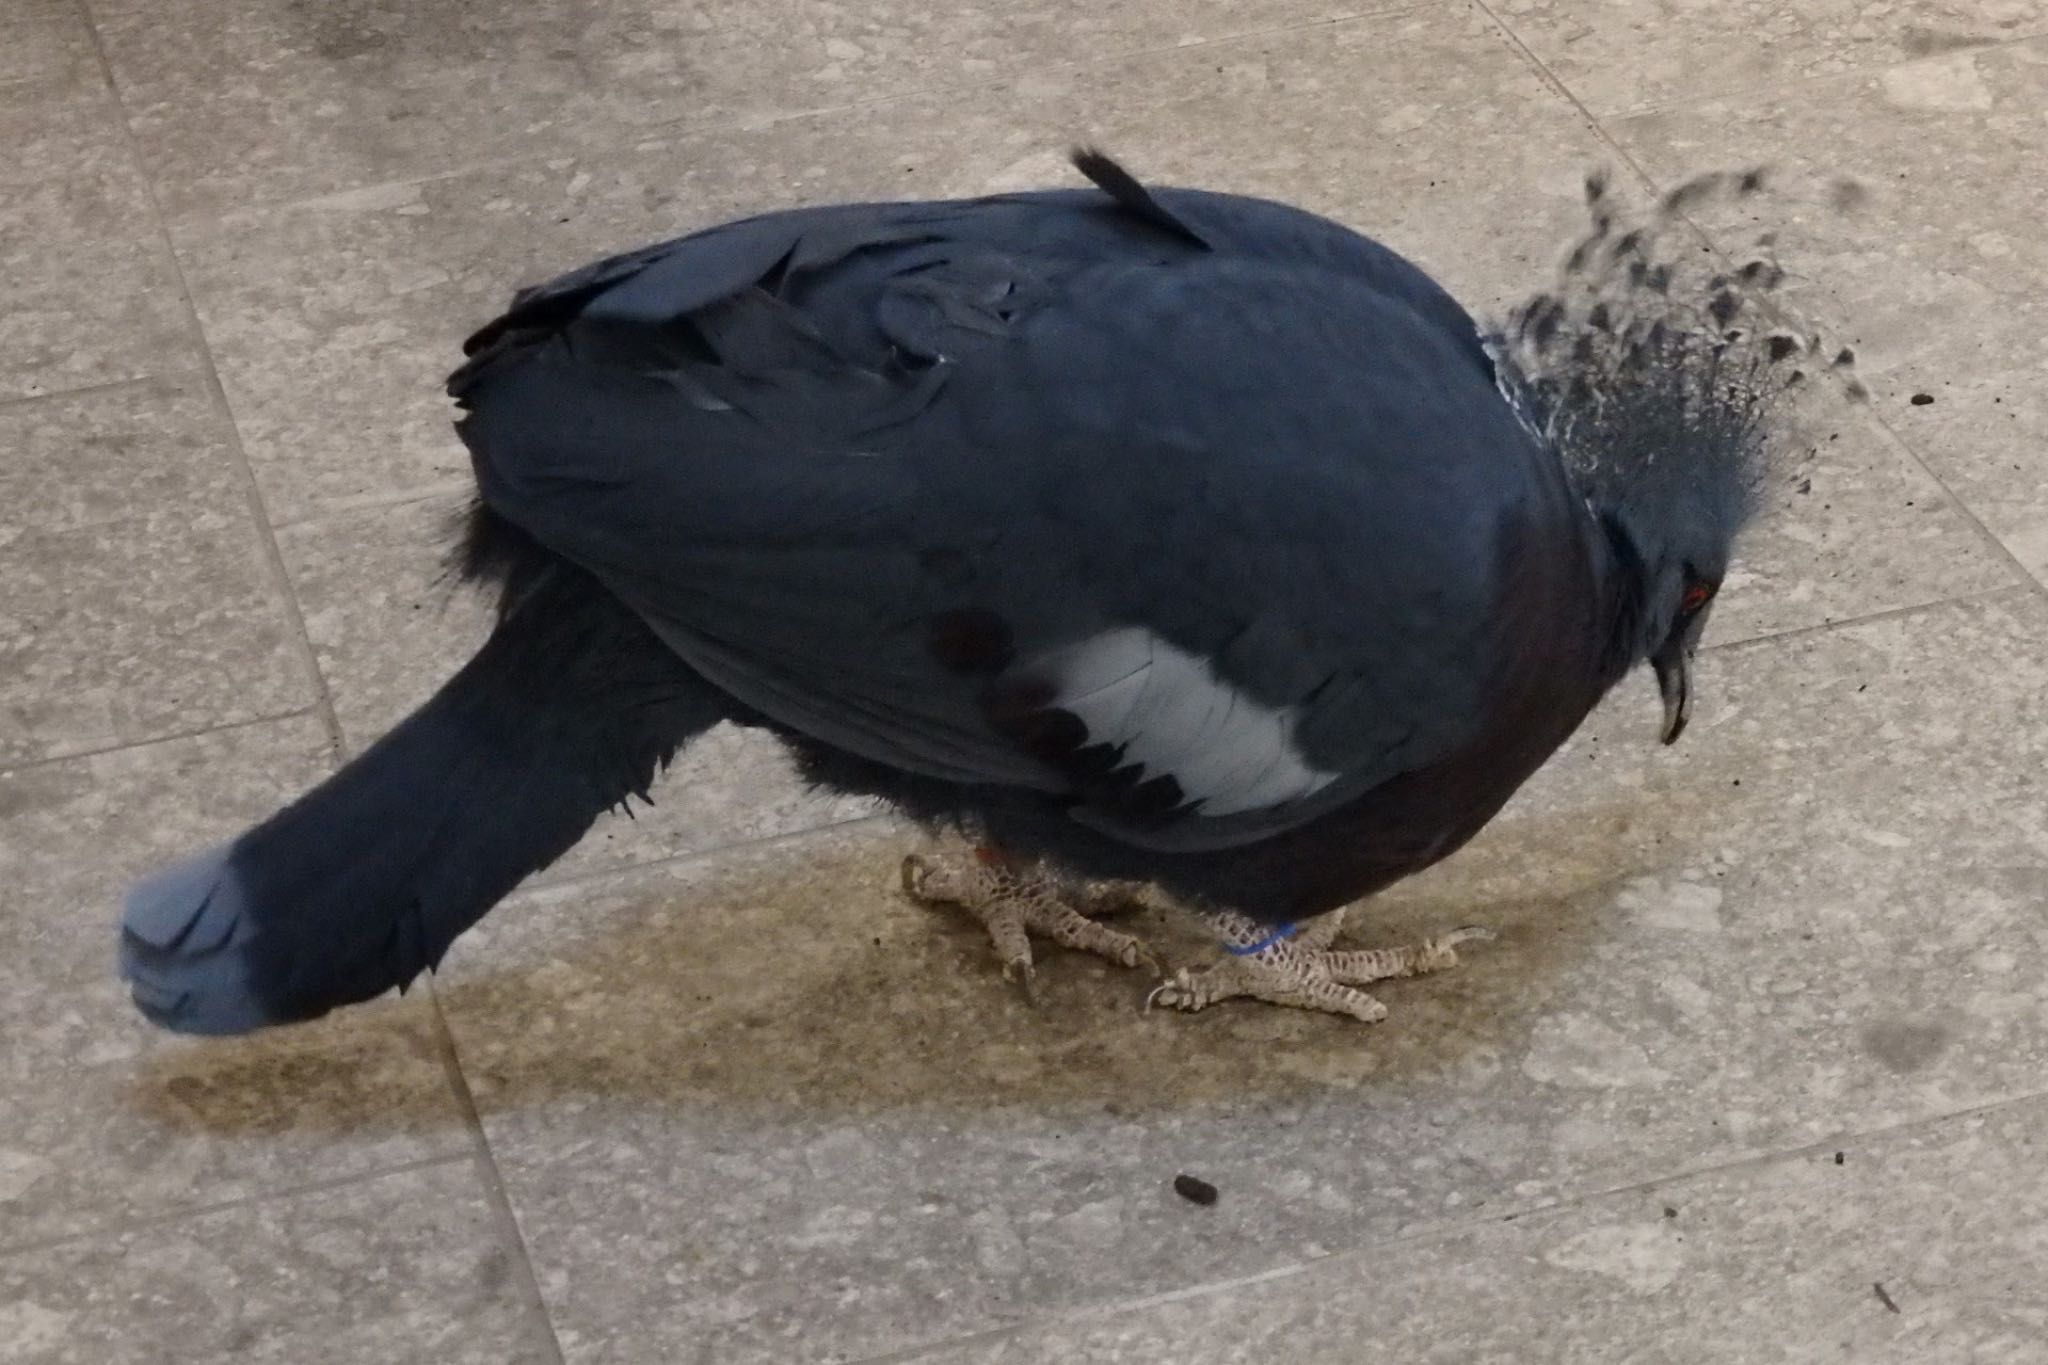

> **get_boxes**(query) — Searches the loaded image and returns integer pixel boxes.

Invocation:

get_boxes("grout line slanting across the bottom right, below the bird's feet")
[840,1091,2048,1365]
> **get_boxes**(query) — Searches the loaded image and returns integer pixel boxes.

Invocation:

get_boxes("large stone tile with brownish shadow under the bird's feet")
[442,593,2048,1363]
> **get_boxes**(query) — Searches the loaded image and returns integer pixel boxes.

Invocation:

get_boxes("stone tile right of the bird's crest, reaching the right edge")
[1614,41,2048,581]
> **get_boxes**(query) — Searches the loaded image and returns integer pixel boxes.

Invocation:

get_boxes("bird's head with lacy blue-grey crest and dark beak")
[1487,172,1864,743]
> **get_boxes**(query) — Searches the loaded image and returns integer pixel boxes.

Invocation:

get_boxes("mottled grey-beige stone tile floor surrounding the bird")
[0,0,2048,1365]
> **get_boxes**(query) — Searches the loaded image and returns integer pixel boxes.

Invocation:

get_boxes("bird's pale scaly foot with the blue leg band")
[1145,907,1493,1023]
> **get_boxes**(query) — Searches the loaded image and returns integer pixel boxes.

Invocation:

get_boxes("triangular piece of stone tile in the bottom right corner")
[915,1101,2048,1365]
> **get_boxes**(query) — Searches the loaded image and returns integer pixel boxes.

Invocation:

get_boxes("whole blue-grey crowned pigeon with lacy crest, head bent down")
[121,151,1825,1033]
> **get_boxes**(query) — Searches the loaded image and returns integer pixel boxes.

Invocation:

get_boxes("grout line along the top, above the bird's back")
[159,0,1436,246]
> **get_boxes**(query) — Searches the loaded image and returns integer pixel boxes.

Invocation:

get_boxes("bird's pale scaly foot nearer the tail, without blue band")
[903,847,1153,1005]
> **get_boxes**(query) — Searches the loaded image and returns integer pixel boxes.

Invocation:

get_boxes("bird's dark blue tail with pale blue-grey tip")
[121,561,725,1033]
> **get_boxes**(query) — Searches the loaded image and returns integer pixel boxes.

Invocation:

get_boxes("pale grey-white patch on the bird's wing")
[1038,626,1341,814]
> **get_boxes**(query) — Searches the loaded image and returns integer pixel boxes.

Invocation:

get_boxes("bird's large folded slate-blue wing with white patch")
[455,165,1554,849]
